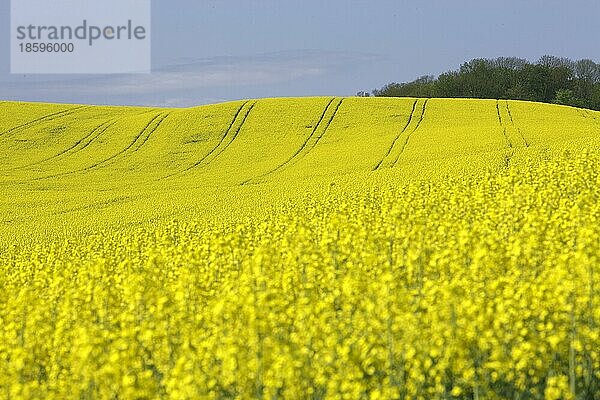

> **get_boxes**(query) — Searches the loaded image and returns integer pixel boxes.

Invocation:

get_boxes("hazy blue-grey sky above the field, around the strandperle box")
[0,0,600,107]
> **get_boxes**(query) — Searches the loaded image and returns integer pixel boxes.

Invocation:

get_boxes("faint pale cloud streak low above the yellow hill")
[3,50,378,106]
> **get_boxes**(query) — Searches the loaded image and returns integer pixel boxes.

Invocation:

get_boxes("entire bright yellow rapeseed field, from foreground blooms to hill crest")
[0,98,600,400]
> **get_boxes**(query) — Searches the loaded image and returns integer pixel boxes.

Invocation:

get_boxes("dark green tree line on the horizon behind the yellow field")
[366,55,600,110]
